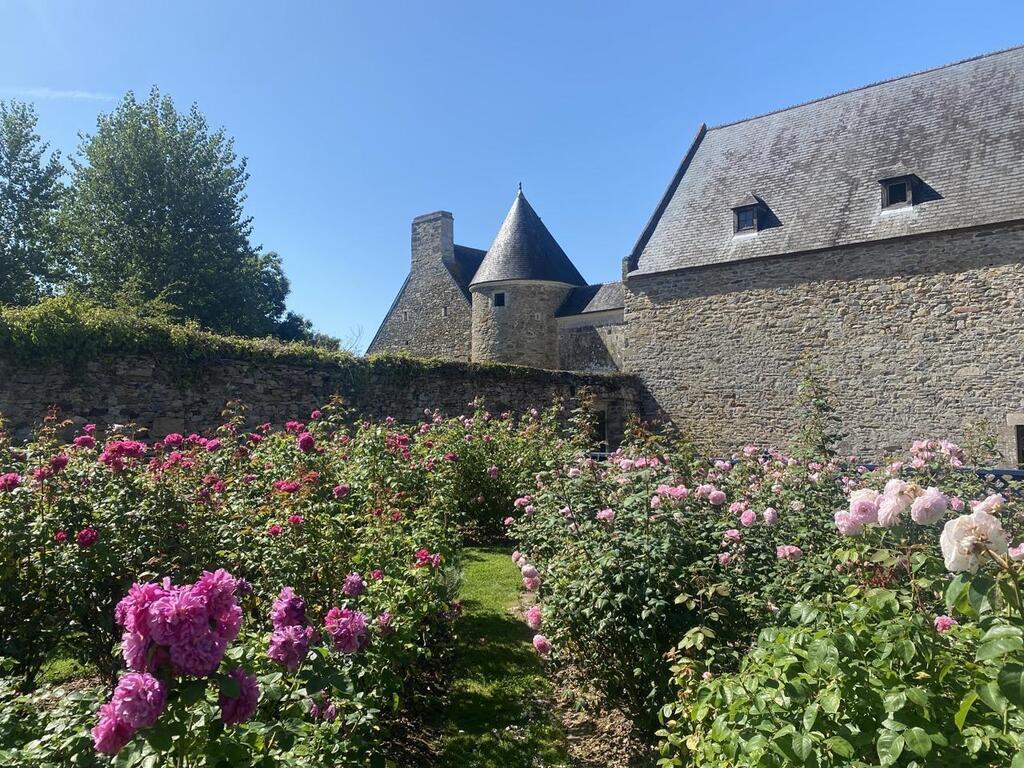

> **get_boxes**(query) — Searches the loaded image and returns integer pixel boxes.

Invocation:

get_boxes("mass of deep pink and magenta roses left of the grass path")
[0,403,566,765]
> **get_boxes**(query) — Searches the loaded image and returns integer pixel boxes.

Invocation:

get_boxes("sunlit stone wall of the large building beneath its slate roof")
[625,224,1024,464]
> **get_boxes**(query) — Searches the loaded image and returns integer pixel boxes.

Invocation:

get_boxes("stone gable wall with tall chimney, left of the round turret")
[368,211,470,361]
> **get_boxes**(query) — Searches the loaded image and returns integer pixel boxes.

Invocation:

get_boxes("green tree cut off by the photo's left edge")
[0,101,63,304]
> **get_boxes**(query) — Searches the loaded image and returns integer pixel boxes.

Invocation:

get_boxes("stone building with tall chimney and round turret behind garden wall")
[368,187,625,372]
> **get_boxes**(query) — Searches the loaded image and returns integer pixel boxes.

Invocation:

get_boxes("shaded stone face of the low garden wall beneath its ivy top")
[0,353,640,441]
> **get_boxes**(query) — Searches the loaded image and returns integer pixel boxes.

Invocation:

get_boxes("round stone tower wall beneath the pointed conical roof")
[472,281,569,369]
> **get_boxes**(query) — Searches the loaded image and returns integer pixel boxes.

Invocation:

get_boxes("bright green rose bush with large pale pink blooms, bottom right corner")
[659,441,1024,767]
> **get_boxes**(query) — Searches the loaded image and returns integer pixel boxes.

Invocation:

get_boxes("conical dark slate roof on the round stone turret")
[470,187,587,286]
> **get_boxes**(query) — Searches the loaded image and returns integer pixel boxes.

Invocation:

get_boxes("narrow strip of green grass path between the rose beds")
[439,549,568,768]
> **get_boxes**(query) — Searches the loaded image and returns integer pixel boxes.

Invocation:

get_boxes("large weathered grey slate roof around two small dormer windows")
[627,47,1024,273]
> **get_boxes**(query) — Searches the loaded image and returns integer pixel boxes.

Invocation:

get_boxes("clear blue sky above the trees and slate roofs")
[0,0,1024,352]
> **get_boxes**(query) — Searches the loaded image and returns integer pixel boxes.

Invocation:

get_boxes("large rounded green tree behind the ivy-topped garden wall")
[61,88,289,336]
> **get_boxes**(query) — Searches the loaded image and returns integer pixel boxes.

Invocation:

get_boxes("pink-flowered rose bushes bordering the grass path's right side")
[511,436,843,730]
